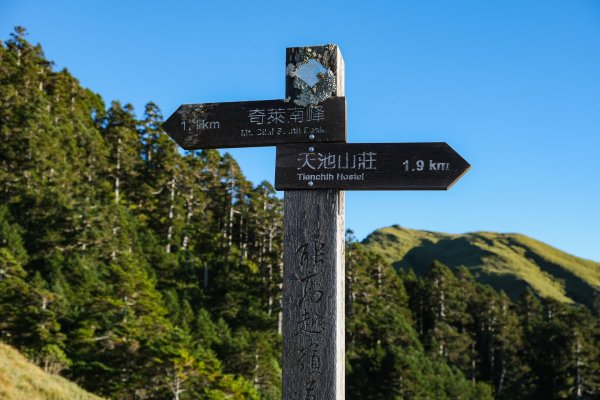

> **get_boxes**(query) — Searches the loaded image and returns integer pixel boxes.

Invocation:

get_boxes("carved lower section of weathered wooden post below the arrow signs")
[283,190,344,400]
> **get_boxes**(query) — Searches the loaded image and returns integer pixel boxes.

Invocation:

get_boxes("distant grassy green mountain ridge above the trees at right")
[364,225,600,304]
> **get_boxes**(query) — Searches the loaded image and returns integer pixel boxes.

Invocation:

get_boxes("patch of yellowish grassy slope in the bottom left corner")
[0,343,102,400]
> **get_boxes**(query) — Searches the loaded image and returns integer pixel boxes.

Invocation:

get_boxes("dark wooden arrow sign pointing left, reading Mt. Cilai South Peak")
[162,97,346,150]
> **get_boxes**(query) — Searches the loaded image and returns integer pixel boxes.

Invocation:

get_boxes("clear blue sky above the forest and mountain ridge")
[0,0,600,261]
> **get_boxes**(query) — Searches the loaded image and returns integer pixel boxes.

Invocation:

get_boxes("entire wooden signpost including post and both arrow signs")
[163,45,470,400]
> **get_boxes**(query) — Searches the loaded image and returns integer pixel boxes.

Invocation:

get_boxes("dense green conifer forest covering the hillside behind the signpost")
[0,27,600,400]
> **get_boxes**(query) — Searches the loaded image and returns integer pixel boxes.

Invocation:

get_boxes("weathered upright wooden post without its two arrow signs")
[283,45,345,400]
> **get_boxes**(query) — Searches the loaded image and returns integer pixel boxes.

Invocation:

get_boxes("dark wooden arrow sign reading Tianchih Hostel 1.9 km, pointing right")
[275,143,471,190]
